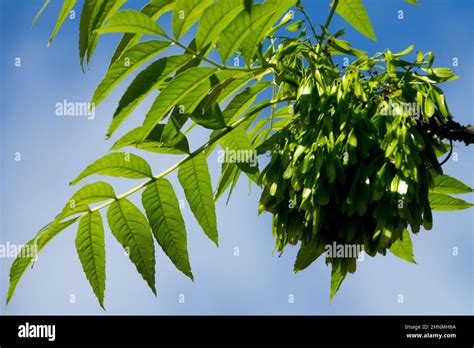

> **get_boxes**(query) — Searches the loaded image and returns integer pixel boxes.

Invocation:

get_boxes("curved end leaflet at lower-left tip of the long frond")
[6,218,78,304]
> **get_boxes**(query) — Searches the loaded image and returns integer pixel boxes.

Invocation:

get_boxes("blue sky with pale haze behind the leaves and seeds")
[0,0,474,314]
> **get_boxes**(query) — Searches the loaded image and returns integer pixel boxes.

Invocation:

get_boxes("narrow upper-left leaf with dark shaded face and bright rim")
[107,54,192,138]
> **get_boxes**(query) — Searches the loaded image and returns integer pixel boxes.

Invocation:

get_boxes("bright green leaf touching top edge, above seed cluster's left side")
[218,3,286,62]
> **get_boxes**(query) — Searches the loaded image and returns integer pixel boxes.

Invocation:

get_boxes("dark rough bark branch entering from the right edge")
[418,118,474,145]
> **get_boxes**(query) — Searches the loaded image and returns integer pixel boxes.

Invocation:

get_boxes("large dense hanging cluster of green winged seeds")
[259,65,444,274]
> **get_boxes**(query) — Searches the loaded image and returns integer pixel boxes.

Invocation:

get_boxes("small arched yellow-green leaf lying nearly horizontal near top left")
[96,10,166,37]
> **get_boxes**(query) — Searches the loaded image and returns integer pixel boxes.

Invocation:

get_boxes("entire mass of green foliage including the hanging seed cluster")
[7,0,472,306]
